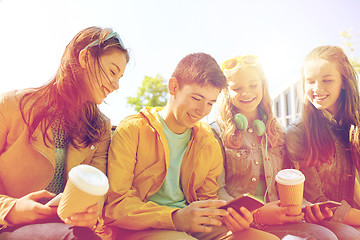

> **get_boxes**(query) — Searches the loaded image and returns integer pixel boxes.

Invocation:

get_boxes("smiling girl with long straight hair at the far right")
[286,46,360,240]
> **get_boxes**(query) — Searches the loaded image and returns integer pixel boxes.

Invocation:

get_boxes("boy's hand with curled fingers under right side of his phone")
[222,207,253,232]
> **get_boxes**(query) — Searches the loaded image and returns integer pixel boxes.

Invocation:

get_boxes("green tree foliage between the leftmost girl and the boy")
[127,75,168,112]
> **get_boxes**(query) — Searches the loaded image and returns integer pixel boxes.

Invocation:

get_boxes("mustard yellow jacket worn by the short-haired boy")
[104,108,222,230]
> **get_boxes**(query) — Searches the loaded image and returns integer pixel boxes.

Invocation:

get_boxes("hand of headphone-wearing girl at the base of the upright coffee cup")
[257,201,304,225]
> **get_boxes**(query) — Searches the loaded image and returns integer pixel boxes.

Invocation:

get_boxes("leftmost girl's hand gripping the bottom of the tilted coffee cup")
[64,204,100,228]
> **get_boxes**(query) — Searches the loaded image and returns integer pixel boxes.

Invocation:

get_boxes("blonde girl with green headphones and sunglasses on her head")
[211,55,337,240]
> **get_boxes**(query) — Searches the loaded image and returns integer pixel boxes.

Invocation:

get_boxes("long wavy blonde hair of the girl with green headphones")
[218,57,284,149]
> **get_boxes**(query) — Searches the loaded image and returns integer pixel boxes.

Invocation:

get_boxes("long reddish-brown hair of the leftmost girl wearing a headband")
[20,27,129,148]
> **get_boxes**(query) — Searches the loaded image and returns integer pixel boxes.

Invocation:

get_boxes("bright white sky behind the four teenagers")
[0,0,360,125]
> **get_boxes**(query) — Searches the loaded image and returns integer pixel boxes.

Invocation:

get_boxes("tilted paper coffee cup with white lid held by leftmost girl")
[57,164,109,221]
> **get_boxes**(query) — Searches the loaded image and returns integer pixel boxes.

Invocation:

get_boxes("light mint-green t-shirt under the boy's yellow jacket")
[148,113,191,208]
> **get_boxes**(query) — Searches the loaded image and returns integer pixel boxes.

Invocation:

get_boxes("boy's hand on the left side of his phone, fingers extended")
[172,200,229,233]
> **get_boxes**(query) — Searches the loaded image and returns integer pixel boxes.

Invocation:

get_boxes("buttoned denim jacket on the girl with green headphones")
[210,122,285,201]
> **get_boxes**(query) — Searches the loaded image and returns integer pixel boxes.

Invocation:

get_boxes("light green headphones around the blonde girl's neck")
[234,108,267,137]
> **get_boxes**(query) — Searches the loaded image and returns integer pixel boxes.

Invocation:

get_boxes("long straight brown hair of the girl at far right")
[301,46,360,168]
